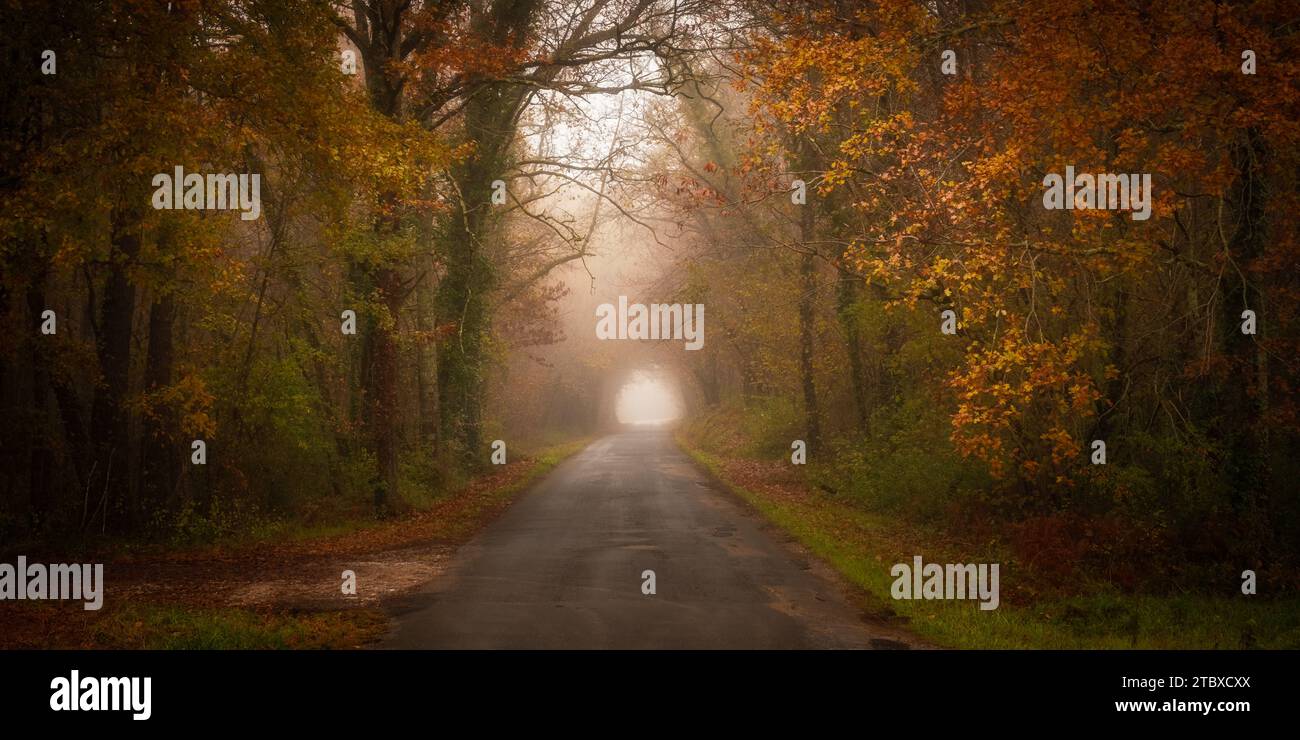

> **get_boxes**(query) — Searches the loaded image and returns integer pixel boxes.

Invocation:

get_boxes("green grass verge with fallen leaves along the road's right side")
[677,436,1300,649]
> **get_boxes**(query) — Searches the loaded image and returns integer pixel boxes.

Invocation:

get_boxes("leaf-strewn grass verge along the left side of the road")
[0,440,589,650]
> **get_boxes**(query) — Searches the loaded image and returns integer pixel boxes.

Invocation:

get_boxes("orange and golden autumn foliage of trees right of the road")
[691,0,1300,572]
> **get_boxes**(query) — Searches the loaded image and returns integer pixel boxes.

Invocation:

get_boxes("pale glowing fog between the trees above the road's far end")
[493,70,707,429]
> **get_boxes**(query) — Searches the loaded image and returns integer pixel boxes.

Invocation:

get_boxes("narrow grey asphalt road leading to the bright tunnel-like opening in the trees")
[381,429,920,649]
